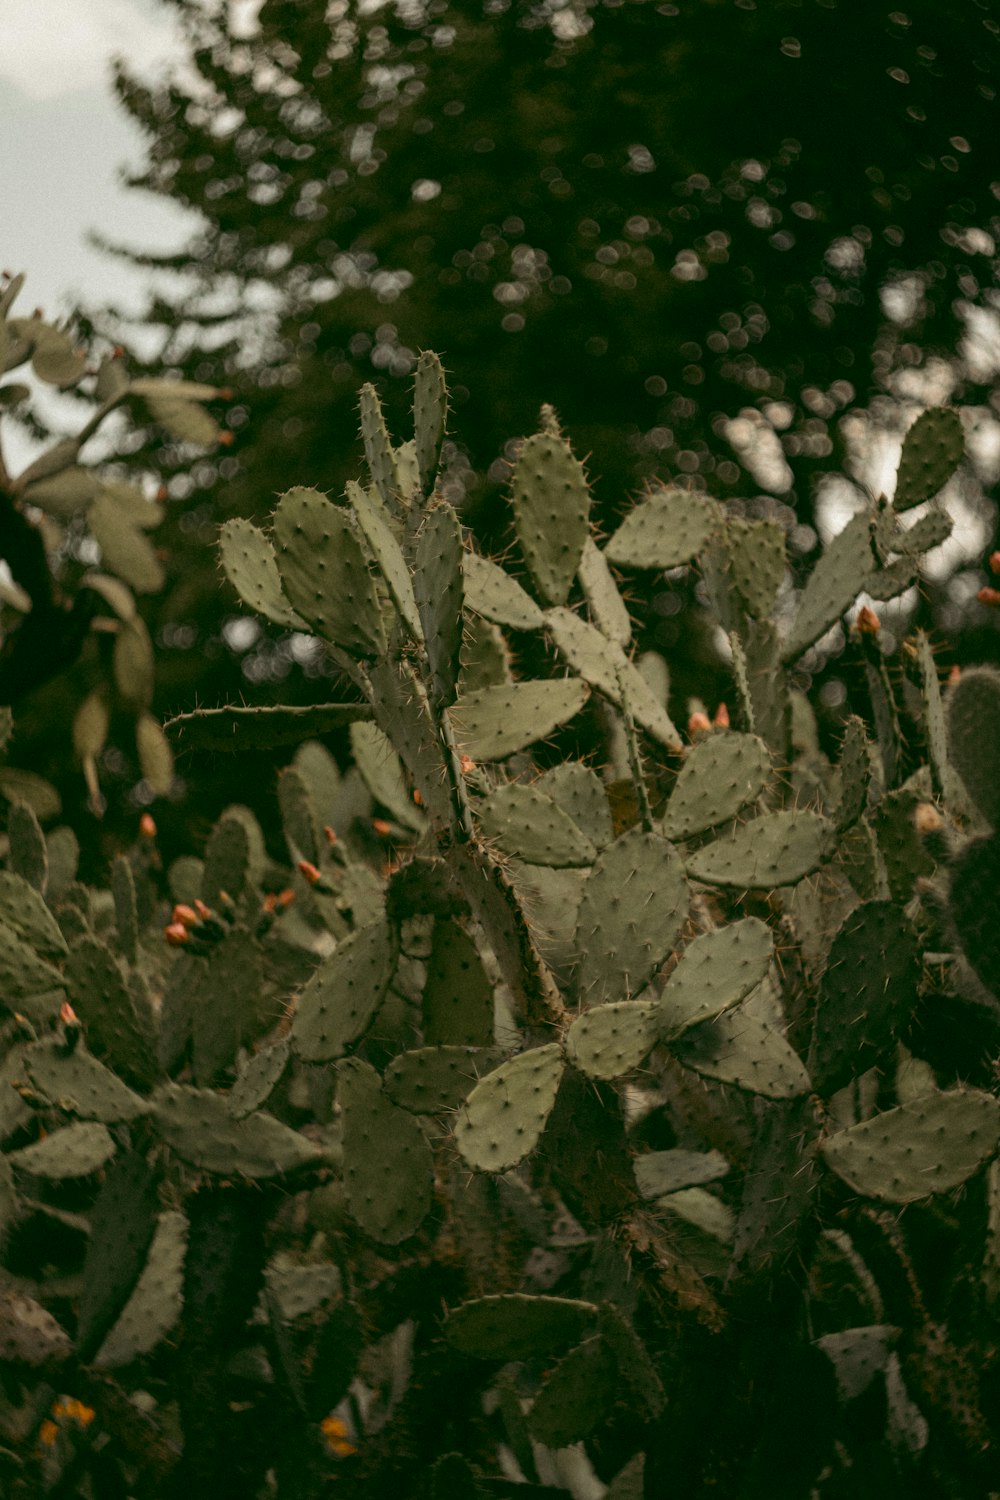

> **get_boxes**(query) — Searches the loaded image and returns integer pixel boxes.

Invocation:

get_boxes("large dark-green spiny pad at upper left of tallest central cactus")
[274,486,385,657]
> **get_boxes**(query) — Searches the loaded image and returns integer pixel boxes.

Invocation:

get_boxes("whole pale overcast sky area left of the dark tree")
[0,0,203,317]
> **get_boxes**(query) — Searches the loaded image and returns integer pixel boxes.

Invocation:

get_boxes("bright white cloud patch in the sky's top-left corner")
[0,0,180,102]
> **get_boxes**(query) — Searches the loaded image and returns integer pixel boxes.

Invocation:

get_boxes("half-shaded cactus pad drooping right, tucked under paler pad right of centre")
[670,1008,810,1100]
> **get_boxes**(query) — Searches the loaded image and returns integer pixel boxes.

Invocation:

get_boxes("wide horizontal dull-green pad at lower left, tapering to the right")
[150,1083,319,1181]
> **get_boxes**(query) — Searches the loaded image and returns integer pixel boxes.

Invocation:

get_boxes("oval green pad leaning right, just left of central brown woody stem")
[291,921,396,1062]
